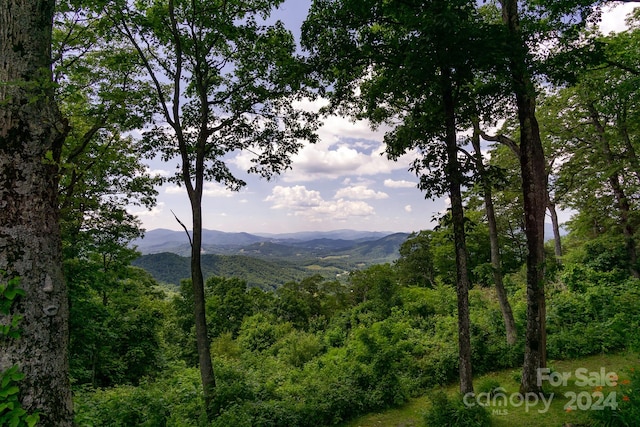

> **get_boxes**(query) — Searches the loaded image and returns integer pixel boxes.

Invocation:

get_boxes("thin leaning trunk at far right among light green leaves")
[587,103,640,278]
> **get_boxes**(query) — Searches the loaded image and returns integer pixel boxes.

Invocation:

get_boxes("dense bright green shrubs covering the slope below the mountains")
[76,265,640,427]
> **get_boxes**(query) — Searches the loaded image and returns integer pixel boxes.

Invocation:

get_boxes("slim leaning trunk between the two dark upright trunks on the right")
[471,123,518,345]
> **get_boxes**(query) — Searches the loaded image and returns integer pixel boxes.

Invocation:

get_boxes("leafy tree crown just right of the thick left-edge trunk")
[53,2,160,252]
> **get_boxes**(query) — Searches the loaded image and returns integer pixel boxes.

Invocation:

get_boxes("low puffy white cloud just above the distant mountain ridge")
[265,185,375,222]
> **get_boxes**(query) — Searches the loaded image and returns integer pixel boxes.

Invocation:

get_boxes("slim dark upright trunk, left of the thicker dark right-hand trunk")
[442,68,473,395]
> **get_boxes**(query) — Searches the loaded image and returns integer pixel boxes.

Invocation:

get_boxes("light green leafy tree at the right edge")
[541,22,640,277]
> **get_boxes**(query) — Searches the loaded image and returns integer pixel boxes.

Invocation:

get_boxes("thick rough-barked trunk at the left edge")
[0,0,73,427]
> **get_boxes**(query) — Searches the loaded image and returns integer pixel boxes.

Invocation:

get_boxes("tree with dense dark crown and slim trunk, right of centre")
[303,0,484,393]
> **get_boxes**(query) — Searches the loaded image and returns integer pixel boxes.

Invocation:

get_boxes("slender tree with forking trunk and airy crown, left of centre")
[105,0,315,418]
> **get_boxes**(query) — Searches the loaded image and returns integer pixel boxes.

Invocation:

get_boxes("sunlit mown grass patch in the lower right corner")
[343,352,640,427]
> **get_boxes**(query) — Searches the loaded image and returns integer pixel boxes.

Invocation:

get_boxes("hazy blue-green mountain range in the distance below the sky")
[133,229,409,289]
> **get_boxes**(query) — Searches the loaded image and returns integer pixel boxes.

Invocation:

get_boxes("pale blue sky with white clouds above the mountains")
[130,0,640,233]
